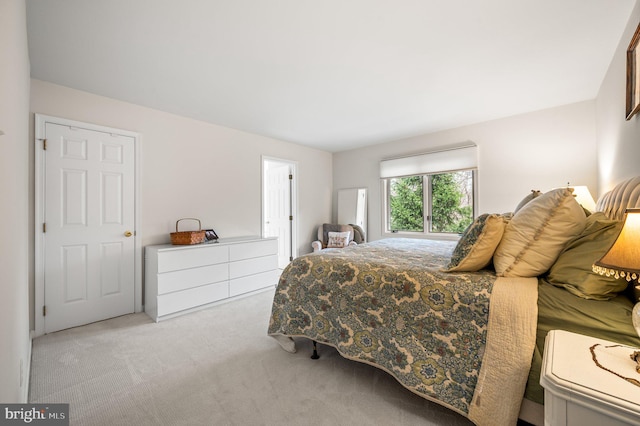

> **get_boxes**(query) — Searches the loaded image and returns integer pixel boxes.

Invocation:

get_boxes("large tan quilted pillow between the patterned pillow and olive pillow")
[493,188,587,277]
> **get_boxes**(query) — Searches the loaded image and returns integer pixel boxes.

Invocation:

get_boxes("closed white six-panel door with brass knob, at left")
[41,122,136,333]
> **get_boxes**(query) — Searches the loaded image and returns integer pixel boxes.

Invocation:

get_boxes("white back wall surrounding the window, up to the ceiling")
[333,101,597,240]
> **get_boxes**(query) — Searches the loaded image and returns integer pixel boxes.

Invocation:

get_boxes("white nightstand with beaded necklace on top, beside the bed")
[540,330,640,426]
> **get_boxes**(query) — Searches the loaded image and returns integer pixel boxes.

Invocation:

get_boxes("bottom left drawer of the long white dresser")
[157,281,229,316]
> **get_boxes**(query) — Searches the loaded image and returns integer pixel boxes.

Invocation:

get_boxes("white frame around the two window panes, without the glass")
[381,167,478,239]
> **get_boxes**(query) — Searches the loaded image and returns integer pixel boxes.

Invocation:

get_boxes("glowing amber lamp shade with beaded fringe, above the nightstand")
[593,209,640,281]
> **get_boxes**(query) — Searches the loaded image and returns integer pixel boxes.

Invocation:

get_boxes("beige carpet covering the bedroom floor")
[29,291,471,426]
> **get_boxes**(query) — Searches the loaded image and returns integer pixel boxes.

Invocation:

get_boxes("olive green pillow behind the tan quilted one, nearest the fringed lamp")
[547,212,628,300]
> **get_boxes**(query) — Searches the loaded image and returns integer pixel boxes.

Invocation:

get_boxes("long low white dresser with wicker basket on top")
[145,237,280,321]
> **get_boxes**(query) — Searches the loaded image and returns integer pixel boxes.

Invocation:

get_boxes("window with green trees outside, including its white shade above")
[380,143,477,234]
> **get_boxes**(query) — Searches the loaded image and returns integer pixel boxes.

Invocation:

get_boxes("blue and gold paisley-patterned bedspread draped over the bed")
[268,238,535,416]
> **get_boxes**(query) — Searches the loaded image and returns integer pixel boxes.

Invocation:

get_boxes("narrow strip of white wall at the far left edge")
[0,0,31,403]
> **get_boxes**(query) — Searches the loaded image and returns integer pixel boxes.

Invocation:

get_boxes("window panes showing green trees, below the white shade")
[385,170,474,234]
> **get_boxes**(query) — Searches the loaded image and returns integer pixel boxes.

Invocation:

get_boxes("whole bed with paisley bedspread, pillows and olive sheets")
[268,178,640,425]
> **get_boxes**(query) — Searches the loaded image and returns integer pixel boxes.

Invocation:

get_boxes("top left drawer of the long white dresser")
[158,245,229,273]
